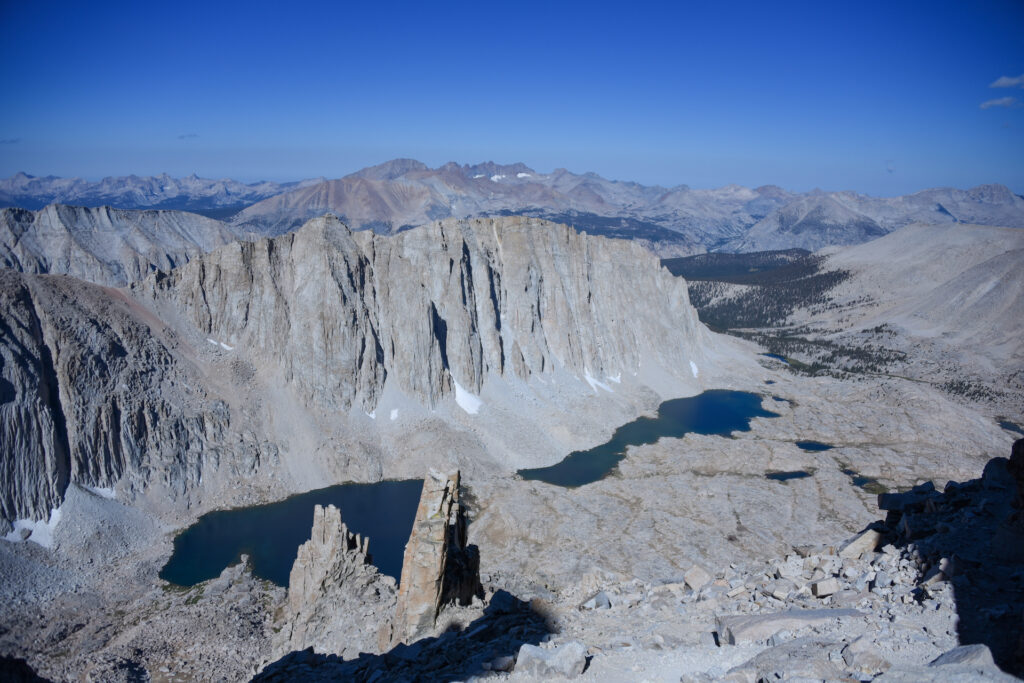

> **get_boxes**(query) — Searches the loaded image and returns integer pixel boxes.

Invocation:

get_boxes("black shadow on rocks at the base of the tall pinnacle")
[252,591,552,683]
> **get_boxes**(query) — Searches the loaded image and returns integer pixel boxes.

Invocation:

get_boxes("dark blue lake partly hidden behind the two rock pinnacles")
[160,479,423,586]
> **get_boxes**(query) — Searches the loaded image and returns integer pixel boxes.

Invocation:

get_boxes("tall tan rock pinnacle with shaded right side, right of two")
[391,470,480,643]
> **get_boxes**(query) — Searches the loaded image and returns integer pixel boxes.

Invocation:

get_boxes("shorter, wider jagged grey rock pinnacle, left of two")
[274,505,395,658]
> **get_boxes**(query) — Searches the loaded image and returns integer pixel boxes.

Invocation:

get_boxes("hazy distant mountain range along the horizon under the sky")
[0,159,1024,256]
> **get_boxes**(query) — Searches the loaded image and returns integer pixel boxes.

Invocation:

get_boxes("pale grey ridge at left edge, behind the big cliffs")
[0,204,236,286]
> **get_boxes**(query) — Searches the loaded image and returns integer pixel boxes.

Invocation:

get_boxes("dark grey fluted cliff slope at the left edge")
[0,270,272,525]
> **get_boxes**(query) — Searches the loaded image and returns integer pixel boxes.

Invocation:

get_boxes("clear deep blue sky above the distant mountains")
[0,0,1024,195]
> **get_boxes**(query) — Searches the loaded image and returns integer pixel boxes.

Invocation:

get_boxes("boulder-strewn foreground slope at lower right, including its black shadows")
[255,439,1024,683]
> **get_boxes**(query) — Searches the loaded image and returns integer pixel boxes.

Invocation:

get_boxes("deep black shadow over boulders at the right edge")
[879,439,1024,677]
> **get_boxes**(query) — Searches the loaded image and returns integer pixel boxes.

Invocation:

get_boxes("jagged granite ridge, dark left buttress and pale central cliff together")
[0,217,708,524]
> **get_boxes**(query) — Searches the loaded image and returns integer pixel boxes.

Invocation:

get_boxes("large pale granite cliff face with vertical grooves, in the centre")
[133,216,708,412]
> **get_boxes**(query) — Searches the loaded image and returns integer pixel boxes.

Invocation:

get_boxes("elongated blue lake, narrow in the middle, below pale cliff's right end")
[519,389,778,487]
